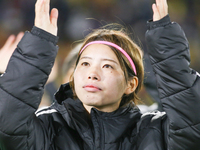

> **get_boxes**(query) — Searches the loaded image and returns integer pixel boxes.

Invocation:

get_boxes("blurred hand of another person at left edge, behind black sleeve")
[0,32,24,73]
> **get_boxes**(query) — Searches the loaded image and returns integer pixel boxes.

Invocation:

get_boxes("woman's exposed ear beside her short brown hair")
[124,76,138,95]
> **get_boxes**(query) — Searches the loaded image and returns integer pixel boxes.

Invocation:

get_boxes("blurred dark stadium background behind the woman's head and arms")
[0,0,200,109]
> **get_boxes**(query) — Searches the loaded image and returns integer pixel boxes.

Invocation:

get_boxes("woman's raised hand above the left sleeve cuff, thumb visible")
[35,0,58,36]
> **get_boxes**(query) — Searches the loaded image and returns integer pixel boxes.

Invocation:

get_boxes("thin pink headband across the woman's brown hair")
[80,41,137,75]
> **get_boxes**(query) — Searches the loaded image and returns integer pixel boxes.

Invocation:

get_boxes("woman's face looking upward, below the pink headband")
[74,44,131,112]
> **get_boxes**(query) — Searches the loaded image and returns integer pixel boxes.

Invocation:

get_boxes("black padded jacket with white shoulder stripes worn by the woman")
[0,16,200,150]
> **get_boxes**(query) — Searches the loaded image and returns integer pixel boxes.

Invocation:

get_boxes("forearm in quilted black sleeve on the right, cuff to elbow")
[146,16,196,98]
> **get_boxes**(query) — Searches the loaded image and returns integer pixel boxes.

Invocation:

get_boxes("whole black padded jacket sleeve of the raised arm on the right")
[146,16,200,150]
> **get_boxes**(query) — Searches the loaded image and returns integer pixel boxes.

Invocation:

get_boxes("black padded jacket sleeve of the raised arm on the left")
[0,27,58,150]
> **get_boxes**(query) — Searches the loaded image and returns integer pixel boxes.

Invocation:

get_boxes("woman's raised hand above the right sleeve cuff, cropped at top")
[152,0,168,21]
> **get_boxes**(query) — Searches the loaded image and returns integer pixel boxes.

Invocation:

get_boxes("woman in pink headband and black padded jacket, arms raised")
[0,0,200,150]
